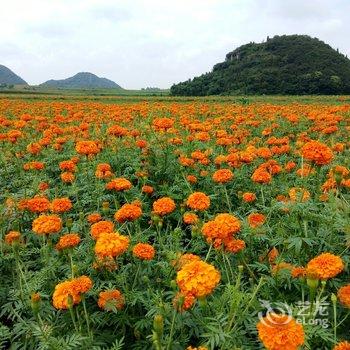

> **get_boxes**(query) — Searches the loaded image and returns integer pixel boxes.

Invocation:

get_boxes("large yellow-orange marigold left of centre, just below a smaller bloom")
[95,232,129,258]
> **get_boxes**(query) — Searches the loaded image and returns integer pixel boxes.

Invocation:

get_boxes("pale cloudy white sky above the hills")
[0,0,350,89]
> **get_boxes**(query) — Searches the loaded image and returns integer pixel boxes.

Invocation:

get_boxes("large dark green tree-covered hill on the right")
[170,35,350,96]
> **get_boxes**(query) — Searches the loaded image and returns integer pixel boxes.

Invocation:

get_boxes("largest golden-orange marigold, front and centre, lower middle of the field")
[176,261,221,298]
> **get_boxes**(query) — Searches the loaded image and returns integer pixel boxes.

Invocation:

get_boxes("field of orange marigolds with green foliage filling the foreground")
[0,97,350,350]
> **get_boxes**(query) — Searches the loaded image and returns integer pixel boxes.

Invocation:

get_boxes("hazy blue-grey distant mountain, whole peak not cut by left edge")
[40,72,122,89]
